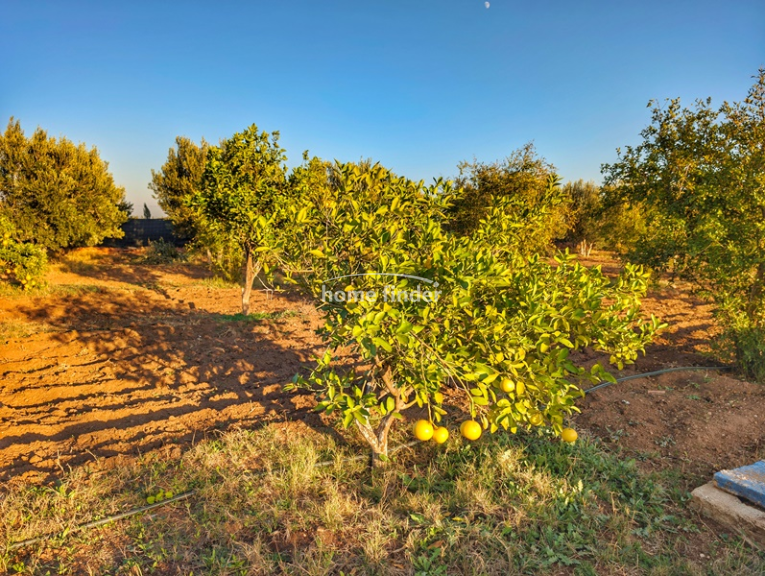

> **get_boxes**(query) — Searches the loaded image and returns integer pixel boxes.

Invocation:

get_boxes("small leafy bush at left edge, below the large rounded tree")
[0,213,48,289]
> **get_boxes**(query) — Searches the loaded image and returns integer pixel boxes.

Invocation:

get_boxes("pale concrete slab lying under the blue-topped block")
[691,482,765,549]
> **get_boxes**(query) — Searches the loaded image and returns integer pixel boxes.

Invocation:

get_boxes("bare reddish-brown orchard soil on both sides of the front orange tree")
[0,248,765,487]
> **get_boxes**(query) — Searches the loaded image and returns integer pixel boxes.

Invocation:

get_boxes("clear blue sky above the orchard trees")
[0,0,765,215]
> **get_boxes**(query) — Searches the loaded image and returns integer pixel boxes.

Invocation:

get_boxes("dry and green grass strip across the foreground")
[0,429,765,576]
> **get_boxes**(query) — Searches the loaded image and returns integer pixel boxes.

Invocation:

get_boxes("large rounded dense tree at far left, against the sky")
[0,118,128,251]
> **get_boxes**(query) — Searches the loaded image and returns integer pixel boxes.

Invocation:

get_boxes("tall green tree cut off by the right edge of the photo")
[603,70,765,380]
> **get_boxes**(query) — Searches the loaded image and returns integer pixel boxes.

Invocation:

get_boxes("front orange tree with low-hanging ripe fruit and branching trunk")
[278,165,660,463]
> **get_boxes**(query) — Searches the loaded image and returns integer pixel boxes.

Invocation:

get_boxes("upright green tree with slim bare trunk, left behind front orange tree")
[189,124,288,314]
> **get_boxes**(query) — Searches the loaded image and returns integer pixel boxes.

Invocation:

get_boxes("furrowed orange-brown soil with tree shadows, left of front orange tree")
[0,290,346,480]
